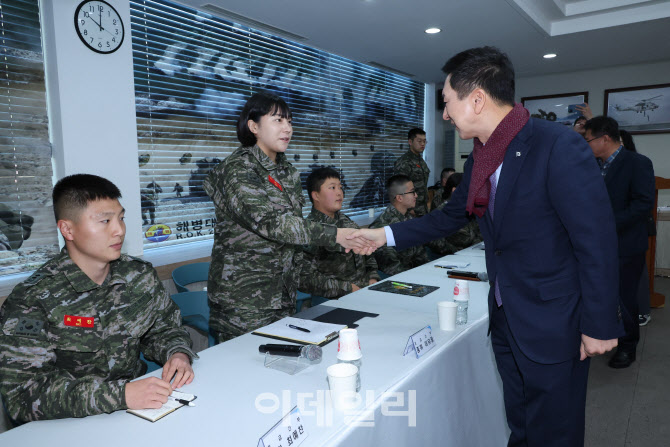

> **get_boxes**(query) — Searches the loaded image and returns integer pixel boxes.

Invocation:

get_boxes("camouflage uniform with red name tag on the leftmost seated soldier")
[0,249,197,422]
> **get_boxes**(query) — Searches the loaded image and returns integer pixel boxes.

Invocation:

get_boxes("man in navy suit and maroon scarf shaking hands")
[355,47,623,447]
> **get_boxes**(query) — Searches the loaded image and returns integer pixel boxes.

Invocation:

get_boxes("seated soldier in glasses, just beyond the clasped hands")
[370,174,429,275]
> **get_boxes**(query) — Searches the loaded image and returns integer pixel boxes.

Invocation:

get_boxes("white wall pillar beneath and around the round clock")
[40,0,142,252]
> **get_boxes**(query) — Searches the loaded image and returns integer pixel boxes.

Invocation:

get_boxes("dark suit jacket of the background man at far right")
[605,149,656,256]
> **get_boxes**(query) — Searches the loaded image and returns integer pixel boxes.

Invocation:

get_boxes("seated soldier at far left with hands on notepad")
[0,174,197,422]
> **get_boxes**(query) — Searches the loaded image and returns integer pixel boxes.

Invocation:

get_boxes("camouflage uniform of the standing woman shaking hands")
[204,146,337,341]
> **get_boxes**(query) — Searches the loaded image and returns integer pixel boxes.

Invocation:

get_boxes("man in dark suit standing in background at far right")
[584,116,655,368]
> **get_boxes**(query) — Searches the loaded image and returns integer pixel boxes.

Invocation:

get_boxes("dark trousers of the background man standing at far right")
[619,253,645,352]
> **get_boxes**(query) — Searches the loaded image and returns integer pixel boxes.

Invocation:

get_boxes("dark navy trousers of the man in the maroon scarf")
[491,304,590,447]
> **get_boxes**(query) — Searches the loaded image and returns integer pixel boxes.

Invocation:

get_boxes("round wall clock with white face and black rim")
[74,0,124,54]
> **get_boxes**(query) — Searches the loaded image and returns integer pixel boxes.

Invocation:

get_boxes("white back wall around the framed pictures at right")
[516,61,670,206]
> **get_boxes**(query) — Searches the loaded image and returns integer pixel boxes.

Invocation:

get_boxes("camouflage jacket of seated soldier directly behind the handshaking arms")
[300,207,379,298]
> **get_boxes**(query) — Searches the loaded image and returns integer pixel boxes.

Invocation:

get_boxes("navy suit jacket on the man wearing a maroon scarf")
[391,118,623,364]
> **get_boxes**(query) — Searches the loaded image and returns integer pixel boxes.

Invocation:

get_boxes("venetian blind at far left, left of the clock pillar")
[0,0,58,275]
